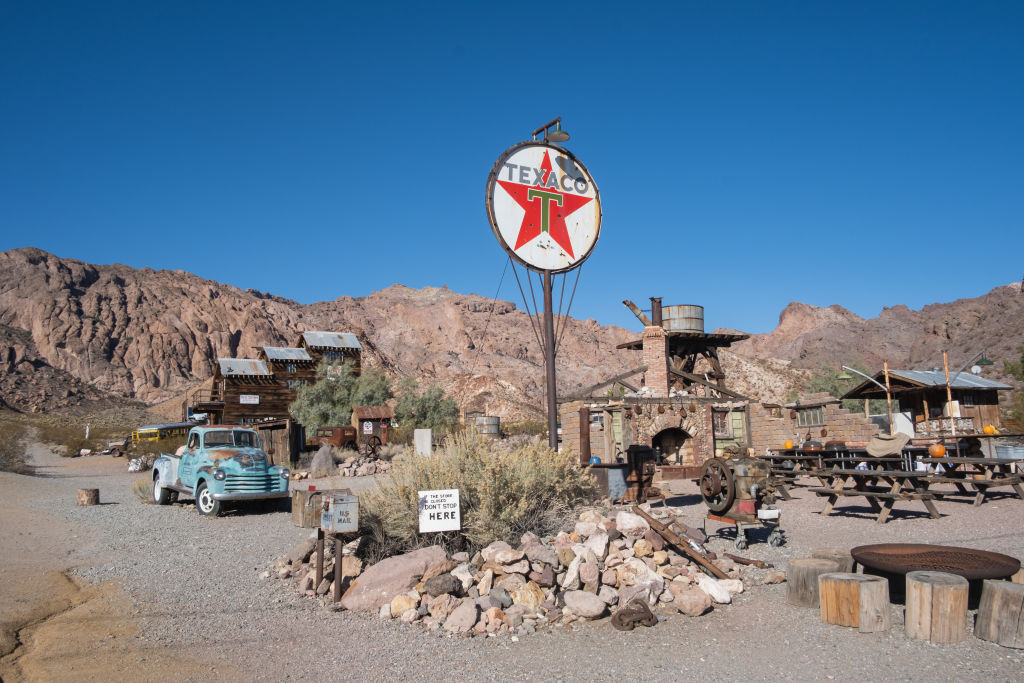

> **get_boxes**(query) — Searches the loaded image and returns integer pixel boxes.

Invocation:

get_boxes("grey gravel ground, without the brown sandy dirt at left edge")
[8,450,1024,681]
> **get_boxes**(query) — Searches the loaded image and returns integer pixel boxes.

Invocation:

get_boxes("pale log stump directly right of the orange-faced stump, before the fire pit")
[905,571,969,644]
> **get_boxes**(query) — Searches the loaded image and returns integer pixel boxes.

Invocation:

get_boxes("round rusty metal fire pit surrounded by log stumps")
[850,543,1021,606]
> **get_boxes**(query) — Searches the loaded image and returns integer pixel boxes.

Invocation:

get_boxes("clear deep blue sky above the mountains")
[0,0,1024,332]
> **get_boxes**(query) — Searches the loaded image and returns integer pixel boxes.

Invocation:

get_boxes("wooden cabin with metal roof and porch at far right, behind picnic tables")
[843,370,1012,436]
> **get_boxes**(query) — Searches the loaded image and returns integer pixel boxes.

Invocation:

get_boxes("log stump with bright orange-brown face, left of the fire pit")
[818,571,889,633]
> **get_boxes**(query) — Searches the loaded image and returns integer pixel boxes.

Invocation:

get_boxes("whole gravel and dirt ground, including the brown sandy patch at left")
[0,447,1024,681]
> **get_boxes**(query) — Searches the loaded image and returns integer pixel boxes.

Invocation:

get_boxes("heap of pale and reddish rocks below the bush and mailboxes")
[263,508,784,637]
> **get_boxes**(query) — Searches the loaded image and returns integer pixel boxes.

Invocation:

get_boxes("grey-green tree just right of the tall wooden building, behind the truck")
[291,360,394,433]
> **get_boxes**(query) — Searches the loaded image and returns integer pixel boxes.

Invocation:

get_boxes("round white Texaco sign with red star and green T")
[486,142,601,272]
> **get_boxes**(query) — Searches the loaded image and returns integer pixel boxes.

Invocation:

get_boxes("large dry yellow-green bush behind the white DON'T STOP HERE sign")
[359,433,596,560]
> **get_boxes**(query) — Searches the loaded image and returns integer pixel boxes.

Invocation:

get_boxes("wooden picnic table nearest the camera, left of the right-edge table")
[810,466,940,524]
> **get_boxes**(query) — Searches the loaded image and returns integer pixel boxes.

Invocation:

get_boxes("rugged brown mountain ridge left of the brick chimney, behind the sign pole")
[0,249,635,419]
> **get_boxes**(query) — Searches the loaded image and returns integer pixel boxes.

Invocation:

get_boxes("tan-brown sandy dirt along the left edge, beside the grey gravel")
[0,444,222,681]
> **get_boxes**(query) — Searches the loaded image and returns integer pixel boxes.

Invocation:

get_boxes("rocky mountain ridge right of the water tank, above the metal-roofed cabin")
[733,283,1024,380]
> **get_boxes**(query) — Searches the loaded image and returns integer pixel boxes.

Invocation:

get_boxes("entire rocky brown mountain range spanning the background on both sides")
[0,248,1024,420]
